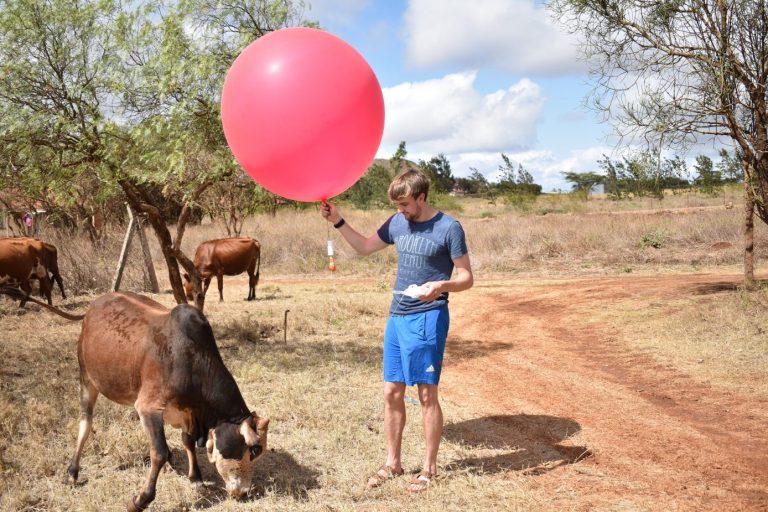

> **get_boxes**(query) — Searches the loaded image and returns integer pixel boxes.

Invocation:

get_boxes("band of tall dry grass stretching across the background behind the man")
[21,192,768,296]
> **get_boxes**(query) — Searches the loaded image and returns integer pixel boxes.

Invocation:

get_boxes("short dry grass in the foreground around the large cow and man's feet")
[0,278,536,511]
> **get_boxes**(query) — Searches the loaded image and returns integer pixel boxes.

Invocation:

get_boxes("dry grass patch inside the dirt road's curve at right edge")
[584,284,768,397]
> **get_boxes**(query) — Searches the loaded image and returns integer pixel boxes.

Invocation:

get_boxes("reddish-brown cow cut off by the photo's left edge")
[0,238,53,307]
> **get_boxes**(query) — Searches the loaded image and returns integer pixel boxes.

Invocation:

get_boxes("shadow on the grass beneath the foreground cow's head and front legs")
[168,448,320,509]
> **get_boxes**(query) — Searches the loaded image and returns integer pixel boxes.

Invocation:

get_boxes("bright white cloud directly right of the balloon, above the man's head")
[379,72,544,157]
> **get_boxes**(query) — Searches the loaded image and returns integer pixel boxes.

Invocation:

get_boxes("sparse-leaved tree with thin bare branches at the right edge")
[549,0,768,285]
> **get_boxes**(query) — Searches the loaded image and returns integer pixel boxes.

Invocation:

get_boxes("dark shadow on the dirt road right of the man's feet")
[443,414,592,474]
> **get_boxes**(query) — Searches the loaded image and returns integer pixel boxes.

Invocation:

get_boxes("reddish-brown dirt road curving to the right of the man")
[441,275,768,511]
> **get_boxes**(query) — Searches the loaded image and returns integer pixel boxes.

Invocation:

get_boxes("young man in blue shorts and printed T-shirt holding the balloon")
[320,170,473,492]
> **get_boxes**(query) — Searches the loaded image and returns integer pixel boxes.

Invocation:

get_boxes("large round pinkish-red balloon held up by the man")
[221,28,384,201]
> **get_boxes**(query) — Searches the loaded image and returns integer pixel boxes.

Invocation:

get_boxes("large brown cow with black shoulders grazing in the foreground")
[0,288,269,512]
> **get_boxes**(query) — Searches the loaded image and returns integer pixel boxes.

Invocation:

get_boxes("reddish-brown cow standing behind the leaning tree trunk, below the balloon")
[184,237,261,301]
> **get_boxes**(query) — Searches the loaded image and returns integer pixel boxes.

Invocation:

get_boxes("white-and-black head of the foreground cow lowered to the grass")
[205,413,269,499]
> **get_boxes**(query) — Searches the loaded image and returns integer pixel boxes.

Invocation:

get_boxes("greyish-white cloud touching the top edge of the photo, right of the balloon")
[404,0,585,75]
